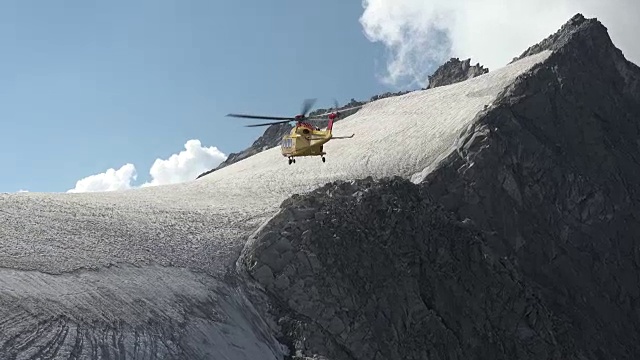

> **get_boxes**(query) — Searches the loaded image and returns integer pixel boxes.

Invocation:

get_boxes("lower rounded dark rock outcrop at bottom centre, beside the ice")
[242,179,573,359]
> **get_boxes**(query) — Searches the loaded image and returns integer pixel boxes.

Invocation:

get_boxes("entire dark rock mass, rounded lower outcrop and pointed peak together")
[241,15,640,359]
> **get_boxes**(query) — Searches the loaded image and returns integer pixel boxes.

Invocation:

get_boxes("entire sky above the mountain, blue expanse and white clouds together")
[0,0,640,192]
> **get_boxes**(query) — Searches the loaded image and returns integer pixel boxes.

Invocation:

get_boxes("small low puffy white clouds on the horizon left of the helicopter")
[68,140,227,193]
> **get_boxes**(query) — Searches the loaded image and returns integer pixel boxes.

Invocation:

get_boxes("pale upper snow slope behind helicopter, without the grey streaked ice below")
[0,52,549,274]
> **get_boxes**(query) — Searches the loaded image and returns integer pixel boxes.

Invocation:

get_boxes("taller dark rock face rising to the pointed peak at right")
[426,12,640,358]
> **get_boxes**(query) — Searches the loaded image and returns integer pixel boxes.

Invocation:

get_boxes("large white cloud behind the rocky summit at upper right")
[360,0,640,86]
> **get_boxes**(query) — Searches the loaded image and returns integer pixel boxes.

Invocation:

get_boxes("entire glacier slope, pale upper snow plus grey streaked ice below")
[0,52,549,358]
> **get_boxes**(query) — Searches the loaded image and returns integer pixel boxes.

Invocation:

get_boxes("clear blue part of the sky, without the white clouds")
[0,0,402,192]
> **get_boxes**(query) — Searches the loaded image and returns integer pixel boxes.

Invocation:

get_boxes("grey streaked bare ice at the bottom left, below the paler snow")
[0,266,284,360]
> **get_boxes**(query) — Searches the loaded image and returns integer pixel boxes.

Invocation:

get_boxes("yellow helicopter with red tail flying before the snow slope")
[227,99,362,165]
